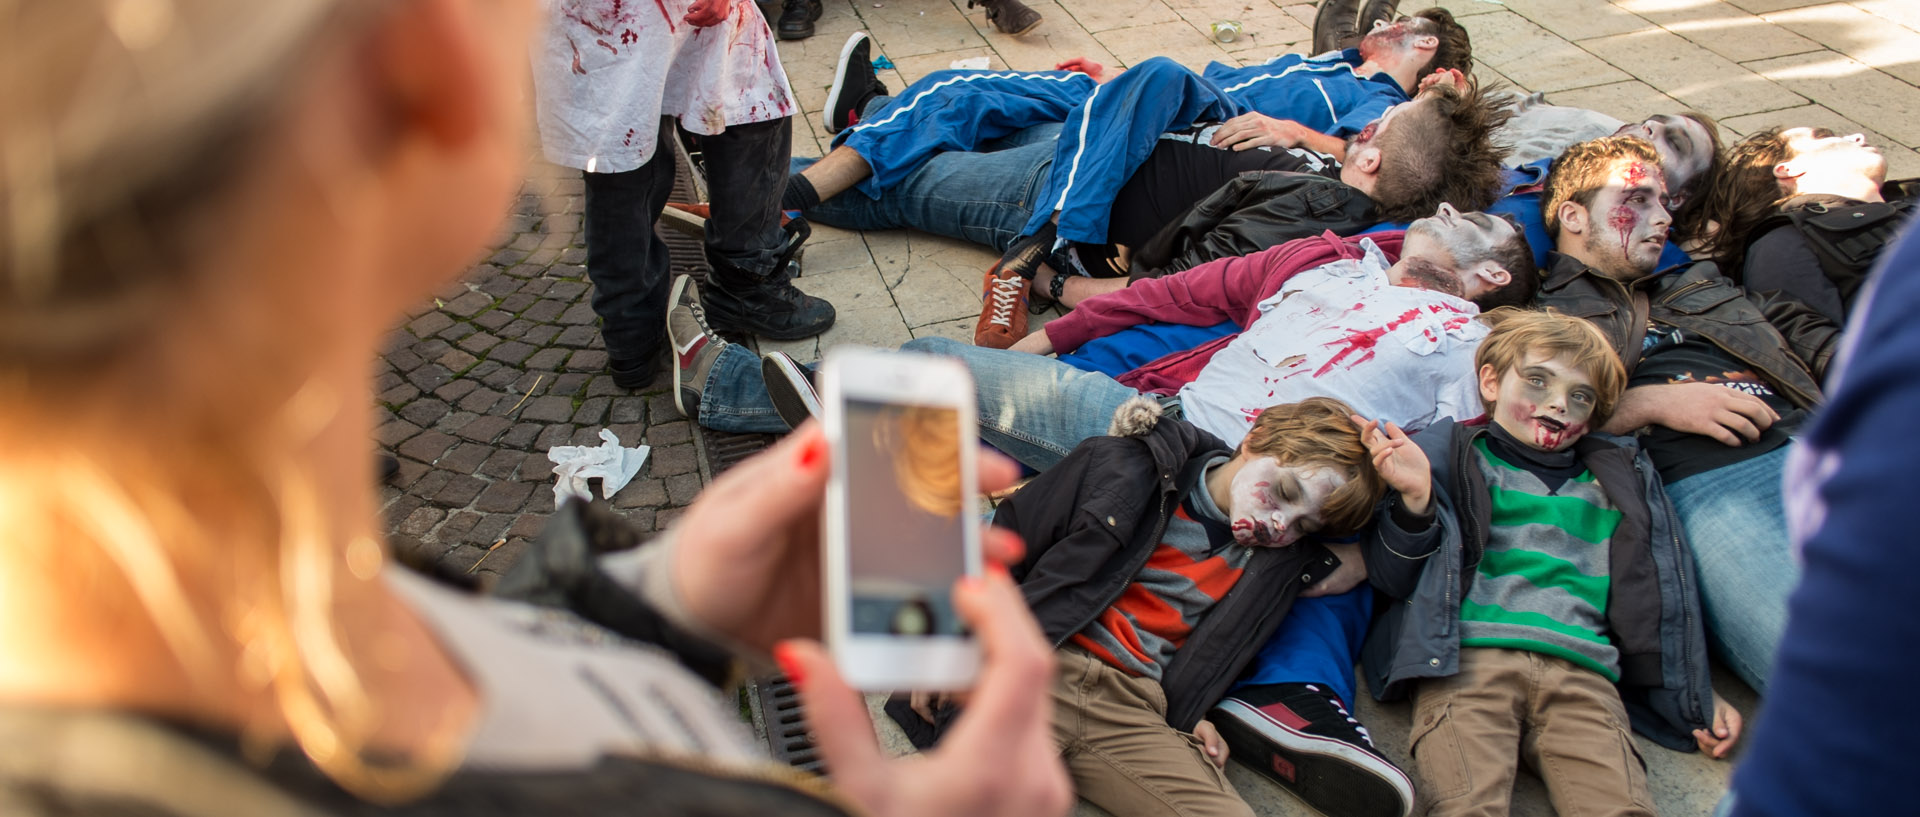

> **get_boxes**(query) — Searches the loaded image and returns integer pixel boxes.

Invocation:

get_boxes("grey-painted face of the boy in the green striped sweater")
[1480,353,1599,451]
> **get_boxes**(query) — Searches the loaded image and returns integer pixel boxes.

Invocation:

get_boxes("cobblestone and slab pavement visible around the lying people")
[376,0,1920,815]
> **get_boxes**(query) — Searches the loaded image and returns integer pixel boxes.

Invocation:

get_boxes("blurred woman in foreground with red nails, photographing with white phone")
[0,0,1068,817]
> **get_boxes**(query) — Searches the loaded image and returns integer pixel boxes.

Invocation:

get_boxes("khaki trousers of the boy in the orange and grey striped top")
[1052,646,1254,817]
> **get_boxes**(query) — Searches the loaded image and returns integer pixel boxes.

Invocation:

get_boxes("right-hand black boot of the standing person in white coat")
[701,219,833,339]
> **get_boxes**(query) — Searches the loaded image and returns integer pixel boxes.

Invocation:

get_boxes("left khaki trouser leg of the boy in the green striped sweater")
[1407,648,1532,817]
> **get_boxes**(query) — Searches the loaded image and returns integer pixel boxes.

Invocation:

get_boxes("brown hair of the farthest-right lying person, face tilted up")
[1697,128,1793,282]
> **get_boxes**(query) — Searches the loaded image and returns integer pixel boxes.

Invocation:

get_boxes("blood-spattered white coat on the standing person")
[532,0,795,173]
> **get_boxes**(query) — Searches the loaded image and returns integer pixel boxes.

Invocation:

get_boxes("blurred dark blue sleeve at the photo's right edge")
[1732,226,1920,817]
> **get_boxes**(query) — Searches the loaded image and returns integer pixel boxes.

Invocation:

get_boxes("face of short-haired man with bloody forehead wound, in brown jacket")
[1586,159,1672,280]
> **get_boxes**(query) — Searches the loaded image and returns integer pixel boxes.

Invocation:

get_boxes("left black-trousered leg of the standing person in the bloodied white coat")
[580,119,674,389]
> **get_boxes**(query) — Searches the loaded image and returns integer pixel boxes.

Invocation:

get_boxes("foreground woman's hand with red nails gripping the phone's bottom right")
[774,562,1073,817]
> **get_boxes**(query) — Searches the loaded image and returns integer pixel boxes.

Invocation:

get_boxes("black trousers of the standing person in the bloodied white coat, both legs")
[580,117,793,362]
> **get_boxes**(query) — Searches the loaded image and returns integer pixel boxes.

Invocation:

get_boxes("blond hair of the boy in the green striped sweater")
[1473,307,1626,428]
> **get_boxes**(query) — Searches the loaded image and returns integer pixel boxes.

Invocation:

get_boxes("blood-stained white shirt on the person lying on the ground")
[1181,242,1486,445]
